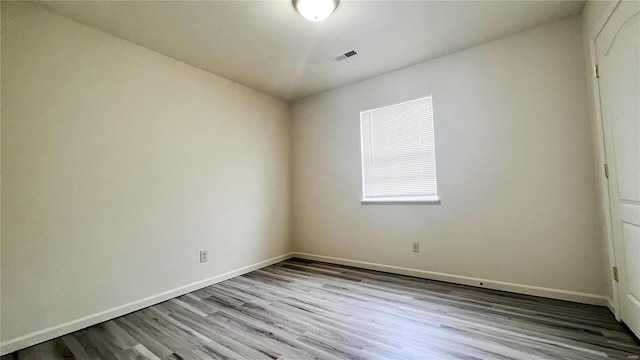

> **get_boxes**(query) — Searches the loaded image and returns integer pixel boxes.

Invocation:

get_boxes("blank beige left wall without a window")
[1,2,291,352]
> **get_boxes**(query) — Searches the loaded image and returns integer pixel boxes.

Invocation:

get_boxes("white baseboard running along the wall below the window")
[293,252,611,307]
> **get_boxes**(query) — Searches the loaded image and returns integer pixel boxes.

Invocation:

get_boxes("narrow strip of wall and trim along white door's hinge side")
[582,1,618,317]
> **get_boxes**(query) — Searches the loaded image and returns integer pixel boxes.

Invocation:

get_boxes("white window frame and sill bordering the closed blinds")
[358,94,441,205]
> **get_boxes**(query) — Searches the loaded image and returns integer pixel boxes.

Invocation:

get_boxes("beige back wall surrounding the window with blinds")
[292,17,604,303]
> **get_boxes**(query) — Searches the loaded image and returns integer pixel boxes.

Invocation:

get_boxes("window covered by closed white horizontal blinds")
[360,96,438,203]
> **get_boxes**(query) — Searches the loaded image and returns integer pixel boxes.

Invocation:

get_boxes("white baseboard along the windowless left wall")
[0,253,293,355]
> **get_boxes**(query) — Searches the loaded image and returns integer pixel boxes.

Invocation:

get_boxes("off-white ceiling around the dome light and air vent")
[37,0,584,100]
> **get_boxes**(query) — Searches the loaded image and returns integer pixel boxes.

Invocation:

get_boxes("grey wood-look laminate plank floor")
[2,259,640,360]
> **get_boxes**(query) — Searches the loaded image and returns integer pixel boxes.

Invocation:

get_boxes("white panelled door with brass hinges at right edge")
[596,0,640,336]
